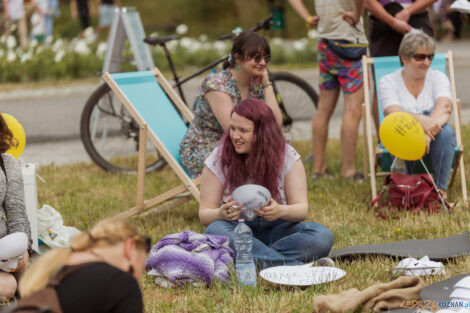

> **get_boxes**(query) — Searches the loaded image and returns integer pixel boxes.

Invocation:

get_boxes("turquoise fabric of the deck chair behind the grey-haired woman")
[373,53,459,173]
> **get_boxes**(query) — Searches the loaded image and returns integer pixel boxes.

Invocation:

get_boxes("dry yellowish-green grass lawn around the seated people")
[38,126,470,312]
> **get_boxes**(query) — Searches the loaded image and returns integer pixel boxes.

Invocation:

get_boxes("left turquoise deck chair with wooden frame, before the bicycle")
[103,68,199,217]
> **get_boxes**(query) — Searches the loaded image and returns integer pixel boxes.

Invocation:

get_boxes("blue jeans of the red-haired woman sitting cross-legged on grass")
[205,216,333,269]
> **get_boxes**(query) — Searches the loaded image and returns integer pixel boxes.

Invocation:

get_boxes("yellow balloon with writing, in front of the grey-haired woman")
[379,112,426,161]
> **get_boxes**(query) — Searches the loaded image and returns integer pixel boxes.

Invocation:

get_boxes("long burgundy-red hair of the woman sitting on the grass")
[219,99,286,202]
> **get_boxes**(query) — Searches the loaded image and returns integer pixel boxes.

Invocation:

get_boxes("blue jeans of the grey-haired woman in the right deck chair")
[406,123,456,190]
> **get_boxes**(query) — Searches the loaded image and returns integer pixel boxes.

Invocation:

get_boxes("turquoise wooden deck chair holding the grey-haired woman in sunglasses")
[362,51,467,202]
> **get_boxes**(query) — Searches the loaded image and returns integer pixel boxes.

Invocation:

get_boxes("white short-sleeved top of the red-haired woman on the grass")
[204,145,300,204]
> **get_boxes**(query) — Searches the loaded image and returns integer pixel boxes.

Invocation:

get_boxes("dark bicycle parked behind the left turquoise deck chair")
[80,16,318,172]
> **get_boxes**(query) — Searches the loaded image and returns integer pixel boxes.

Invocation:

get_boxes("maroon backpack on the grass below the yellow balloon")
[371,173,449,218]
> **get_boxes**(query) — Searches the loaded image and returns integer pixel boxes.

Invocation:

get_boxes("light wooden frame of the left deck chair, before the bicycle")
[103,68,200,217]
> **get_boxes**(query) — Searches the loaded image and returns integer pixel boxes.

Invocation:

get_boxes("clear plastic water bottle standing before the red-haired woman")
[234,219,256,286]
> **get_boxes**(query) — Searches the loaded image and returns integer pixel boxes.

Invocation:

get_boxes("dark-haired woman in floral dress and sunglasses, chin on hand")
[180,31,282,178]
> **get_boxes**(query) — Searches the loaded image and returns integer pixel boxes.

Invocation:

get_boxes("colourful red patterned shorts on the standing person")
[317,40,362,94]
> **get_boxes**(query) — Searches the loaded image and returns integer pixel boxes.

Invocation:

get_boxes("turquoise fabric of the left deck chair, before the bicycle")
[110,71,188,174]
